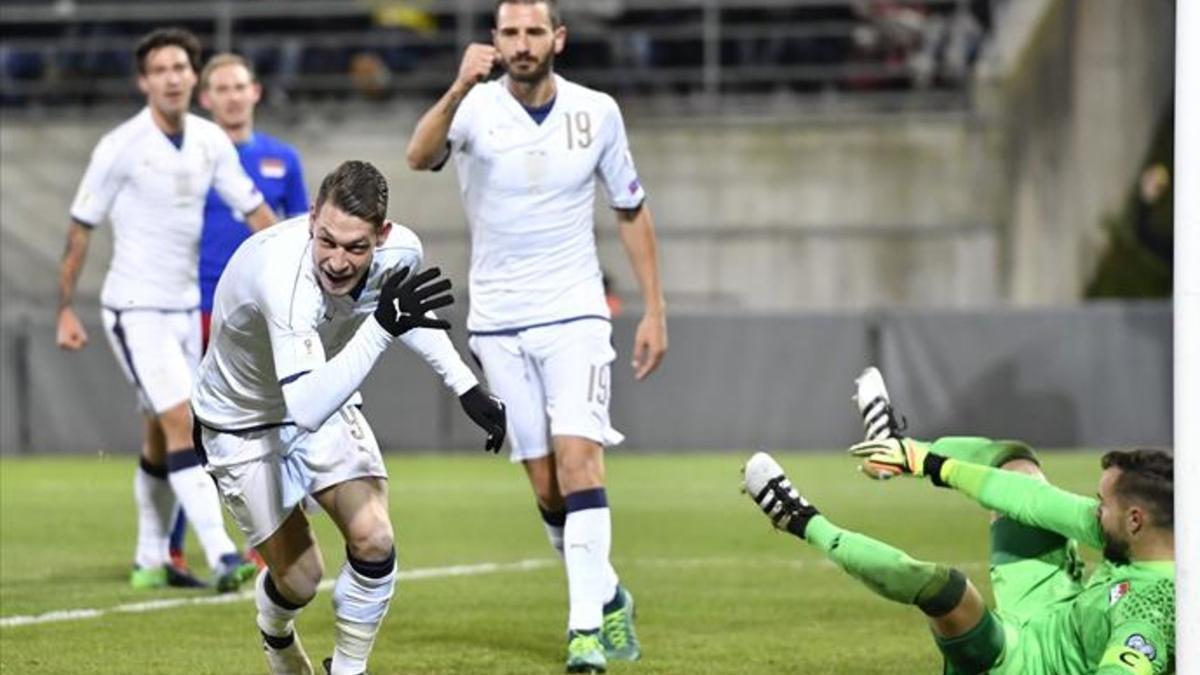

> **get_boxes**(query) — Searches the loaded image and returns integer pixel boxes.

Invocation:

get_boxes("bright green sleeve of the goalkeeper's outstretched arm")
[941,459,1104,549]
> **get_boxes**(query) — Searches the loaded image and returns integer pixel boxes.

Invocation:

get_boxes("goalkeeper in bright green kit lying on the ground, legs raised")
[744,368,1175,675]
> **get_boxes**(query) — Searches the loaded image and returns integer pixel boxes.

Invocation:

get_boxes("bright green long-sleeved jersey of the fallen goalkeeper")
[934,448,1175,675]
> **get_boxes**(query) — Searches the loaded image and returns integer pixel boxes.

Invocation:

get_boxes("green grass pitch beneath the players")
[0,453,1098,675]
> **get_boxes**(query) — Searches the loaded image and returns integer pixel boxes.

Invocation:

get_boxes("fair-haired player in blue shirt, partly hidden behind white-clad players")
[170,53,308,568]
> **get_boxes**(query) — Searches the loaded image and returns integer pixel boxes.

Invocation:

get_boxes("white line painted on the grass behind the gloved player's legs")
[0,558,559,628]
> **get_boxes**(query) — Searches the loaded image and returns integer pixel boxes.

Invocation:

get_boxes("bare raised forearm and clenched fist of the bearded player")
[406,43,499,171]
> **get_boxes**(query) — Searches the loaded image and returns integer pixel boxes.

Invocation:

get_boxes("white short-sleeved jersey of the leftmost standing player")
[71,108,263,310]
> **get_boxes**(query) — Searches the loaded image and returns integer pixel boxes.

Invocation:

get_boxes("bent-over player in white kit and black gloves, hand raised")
[192,161,504,675]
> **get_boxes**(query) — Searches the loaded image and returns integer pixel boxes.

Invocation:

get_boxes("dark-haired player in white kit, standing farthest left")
[58,29,275,591]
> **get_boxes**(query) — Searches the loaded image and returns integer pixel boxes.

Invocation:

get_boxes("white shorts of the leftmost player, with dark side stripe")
[101,307,202,414]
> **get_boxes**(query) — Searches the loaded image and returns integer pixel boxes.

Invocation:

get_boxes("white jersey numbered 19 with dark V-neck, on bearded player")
[448,76,646,334]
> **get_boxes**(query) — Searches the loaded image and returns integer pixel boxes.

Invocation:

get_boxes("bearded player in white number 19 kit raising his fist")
[408,0,667,673]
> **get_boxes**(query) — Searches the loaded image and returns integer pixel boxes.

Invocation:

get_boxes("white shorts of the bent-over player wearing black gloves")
[200,405,388,546]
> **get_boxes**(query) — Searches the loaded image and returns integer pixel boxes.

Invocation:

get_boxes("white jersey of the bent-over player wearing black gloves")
[192,214,422,431]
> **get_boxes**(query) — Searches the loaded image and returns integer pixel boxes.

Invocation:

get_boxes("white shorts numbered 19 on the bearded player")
[469,318,625,462]
